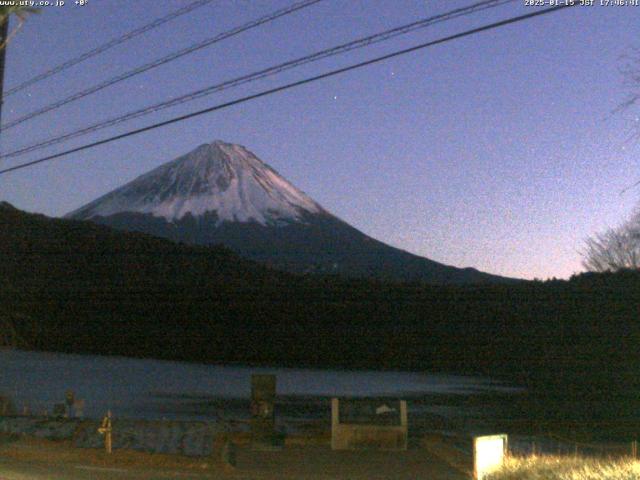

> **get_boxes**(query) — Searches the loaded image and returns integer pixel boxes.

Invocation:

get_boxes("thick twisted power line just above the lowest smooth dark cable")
[0,0,517,159]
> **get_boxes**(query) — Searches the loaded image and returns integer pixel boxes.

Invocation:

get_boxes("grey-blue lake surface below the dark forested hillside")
[0,349,517,420]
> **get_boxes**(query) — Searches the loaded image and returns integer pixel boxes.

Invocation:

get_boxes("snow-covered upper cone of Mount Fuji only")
[68,140,324,225]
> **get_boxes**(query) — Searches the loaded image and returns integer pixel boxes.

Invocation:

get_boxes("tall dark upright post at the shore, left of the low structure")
[251,375,277,450]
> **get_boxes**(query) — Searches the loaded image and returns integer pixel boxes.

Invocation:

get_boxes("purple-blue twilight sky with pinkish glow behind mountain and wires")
[0,0,640,278]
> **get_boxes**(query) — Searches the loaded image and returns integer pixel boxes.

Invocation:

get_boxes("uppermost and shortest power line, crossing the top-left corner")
[4,0,214,98]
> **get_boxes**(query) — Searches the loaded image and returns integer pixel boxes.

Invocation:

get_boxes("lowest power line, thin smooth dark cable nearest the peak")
[0,3,578,175]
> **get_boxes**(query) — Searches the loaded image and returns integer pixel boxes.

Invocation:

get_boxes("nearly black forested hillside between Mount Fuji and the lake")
[0,205,640,398]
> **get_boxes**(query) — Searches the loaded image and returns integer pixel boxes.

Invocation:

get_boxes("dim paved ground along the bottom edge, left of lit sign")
[0,445,468,480]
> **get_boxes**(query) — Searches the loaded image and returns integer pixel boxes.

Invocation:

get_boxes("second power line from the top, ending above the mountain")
[0,0,323,131]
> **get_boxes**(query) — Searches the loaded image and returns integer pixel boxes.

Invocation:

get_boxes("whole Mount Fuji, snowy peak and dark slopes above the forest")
[66,141,512,283]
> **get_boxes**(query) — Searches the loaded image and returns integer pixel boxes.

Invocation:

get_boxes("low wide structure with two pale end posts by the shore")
[331,398,408,450]
